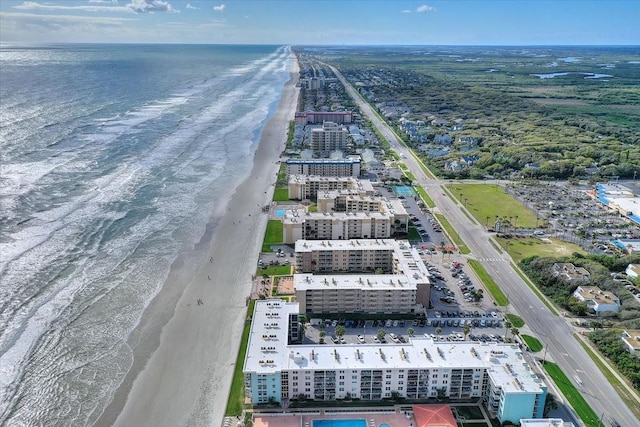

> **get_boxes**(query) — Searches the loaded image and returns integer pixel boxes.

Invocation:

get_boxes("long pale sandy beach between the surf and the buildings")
[95,54,299,426]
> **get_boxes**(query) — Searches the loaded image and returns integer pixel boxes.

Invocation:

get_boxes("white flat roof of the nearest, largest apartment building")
[244,300,544,393]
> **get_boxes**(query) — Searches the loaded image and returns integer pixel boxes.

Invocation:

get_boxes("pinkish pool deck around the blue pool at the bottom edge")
[253,410,416,427]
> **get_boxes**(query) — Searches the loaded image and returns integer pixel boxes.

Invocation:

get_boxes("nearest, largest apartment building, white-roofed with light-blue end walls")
[243,300,547,423]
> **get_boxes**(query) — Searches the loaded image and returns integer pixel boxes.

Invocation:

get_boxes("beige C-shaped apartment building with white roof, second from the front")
[294,239,431,314]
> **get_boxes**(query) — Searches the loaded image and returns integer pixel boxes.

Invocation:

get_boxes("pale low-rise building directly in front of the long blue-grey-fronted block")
[288,175,376,200]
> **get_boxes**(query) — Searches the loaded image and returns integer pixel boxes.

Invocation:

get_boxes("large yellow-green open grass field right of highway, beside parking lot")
[447,183,536,228]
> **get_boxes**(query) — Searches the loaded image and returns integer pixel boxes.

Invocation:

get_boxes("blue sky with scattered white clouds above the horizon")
[0,0,640,45]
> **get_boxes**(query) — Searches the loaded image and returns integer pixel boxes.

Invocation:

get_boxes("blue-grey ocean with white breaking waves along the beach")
[0,45,293,426]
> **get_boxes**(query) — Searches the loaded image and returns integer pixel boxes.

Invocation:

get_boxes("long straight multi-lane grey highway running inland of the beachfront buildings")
[327,65,640,427]
